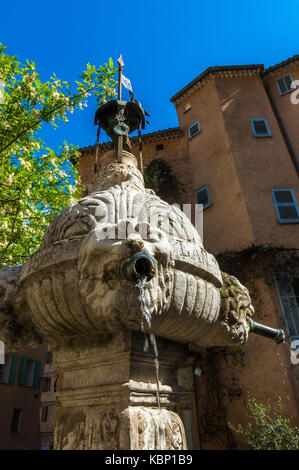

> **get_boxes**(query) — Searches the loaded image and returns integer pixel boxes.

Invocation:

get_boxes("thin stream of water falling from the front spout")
[138,277,161,409]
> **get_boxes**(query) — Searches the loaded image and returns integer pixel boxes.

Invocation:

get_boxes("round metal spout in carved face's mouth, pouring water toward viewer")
[121,253,158,282]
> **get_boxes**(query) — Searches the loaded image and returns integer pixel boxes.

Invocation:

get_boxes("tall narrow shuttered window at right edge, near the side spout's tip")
[275,272,299,341]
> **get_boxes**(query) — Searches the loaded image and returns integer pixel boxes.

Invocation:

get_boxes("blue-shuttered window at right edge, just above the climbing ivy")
[271,188,299,224]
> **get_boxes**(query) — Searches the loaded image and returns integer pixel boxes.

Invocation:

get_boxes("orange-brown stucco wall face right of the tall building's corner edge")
[216,77,299,247]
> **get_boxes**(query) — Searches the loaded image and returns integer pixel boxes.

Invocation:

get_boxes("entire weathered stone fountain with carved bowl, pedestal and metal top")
[0,94,284,450]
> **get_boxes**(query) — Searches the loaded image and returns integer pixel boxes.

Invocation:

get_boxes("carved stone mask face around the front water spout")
[78,219,174,331]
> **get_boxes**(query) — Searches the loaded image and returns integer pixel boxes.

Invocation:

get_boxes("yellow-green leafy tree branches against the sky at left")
[0,44,117,267]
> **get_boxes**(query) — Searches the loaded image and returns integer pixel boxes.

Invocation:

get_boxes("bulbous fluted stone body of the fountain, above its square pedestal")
[21,151,237,343]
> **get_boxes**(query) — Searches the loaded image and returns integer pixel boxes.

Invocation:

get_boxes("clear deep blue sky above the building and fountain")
[0,0,299,149]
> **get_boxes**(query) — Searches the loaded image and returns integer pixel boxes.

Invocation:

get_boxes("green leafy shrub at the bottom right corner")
[230,395,299,450]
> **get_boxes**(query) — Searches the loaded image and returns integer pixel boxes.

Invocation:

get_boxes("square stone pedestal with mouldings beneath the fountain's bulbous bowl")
[54,331,197,450]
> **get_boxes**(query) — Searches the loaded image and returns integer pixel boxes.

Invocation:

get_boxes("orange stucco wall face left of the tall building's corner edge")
[177,81,253,253]
